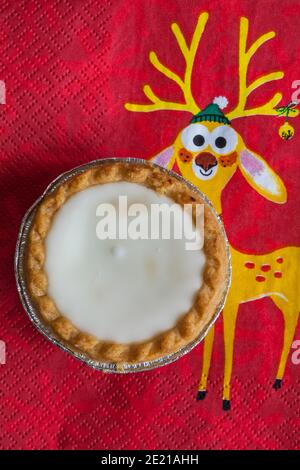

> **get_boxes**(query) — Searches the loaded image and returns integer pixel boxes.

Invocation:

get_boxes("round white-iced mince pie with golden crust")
[19,159,229,371]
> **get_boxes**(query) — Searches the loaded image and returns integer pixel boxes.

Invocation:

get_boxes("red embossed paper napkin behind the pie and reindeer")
[0,0,300,449]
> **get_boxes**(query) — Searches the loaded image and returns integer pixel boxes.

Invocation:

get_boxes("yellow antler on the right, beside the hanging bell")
[227,17,298,120]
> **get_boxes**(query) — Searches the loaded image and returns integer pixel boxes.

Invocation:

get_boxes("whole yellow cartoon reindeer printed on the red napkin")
[125,12,300,410]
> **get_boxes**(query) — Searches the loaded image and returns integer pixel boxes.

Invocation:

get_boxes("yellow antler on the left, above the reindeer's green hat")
[125,12,208,114]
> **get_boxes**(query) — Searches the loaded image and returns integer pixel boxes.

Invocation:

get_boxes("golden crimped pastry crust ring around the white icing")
[26,160,229,369]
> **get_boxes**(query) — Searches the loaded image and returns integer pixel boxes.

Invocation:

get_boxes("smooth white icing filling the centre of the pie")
[45,182,205,343]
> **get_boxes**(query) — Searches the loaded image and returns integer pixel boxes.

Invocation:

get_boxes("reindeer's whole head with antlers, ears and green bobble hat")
[125,12,292,212]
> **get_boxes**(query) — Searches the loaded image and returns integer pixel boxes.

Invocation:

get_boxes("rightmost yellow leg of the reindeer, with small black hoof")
[272,296,299,390]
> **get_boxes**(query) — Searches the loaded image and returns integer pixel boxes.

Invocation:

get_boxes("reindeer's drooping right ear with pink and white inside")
[239,148,287,204]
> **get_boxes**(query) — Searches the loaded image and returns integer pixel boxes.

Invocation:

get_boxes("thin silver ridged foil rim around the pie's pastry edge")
[14,157,231,373]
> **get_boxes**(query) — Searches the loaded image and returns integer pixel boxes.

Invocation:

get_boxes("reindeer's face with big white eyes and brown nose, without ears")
[174,122,241,184]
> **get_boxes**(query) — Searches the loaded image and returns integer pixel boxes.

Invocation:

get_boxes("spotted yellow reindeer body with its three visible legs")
[198,246,300,409]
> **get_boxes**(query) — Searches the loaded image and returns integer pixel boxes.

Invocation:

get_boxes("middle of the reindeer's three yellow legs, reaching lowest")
[223,298,239,411]
